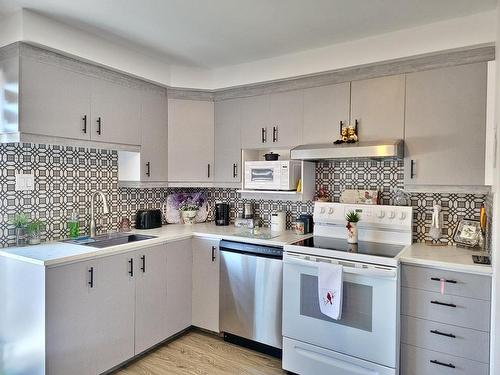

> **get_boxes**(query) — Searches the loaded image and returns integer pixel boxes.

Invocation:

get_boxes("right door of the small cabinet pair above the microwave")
[268,90,304,147]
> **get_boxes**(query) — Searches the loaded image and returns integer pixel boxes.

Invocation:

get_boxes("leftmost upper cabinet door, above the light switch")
[20,57,92,139]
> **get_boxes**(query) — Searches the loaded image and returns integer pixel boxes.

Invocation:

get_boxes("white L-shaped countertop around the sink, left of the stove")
[0,223,311,266]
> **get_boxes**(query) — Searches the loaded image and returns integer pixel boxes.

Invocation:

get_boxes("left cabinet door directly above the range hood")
[302,82,351,144]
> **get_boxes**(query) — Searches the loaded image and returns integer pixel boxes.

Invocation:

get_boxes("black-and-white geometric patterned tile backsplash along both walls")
[0,143,491,247]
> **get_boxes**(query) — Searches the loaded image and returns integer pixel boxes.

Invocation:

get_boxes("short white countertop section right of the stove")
[399,243,493,275]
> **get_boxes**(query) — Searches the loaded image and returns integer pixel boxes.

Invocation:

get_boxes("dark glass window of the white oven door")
[300,274,373,332]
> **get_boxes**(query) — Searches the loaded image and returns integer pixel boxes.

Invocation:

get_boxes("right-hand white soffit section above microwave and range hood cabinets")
[208,11,496,87]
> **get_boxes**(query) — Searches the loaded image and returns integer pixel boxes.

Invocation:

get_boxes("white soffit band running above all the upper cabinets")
[0,10,496,89]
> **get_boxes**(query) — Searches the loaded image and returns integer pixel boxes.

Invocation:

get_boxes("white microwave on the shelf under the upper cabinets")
[244,160,301,190]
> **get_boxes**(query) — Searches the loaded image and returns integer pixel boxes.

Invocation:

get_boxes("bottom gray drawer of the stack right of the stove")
[400,344,489,375]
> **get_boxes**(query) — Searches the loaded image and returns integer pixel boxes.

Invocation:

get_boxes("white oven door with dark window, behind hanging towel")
[283,253,399,368]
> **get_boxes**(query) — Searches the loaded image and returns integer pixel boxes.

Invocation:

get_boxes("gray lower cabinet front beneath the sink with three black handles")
[45,239,192,375]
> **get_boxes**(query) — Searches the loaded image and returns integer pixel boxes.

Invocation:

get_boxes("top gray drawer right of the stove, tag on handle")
[401,264,491,301]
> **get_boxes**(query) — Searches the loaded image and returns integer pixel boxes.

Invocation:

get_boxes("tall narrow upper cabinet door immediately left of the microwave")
[215,99,241,182]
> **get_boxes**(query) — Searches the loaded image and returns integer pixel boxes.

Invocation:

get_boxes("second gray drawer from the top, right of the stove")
[401,288,490,332]
